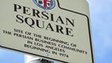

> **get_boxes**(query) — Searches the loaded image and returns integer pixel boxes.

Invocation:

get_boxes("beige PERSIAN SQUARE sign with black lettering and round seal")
[0,0,94,63]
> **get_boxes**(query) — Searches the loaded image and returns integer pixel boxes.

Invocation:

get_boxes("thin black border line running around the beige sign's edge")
[0,0,94,63]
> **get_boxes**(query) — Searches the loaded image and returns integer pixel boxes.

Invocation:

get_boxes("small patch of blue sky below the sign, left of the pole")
[0,48,24,63]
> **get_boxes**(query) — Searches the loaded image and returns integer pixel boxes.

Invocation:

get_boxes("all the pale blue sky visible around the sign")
[0,0,112,63]
